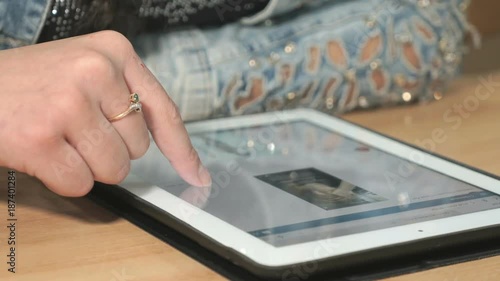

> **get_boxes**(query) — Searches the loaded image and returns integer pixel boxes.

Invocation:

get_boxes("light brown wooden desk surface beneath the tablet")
[0,72,500,281]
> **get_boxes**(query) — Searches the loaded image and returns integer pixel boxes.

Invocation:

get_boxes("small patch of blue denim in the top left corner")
[0,0,50,50]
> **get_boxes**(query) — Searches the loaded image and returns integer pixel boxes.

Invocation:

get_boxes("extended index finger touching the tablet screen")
[124,55,212,187]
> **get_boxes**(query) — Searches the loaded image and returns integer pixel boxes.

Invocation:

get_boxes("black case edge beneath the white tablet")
[89,183,500,281]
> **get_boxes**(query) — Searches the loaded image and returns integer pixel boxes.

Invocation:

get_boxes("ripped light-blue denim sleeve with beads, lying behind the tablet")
[134,0,473,120]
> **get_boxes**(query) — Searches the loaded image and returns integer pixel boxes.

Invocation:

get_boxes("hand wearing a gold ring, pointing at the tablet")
[0,31,211,196]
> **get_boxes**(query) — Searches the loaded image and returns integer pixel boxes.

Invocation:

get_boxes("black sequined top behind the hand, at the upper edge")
[39,0,269,42]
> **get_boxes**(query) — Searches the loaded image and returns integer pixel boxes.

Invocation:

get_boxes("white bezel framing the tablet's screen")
[120,109,500,267]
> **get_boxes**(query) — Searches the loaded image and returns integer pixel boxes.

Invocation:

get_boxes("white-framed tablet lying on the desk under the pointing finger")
[114,109,500,280]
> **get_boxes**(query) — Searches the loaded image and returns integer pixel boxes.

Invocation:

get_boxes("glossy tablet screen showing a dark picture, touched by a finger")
[132,121,500,247]
